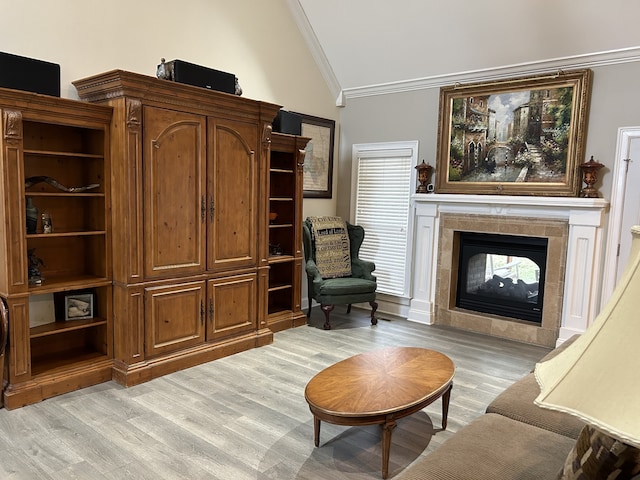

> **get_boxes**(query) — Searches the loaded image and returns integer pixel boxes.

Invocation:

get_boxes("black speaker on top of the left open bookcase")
[0,52,60,97]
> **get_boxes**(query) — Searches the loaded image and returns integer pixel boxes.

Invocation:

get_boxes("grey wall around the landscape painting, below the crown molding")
[337,61,640,216]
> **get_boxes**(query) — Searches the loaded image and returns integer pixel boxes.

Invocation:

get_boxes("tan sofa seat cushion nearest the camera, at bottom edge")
[395,413,575,480]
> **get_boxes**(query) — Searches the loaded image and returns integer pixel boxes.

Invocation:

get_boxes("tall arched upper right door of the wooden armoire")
[208,118,258,270]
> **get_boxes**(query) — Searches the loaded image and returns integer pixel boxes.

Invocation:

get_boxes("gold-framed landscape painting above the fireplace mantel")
[436,69,591,196]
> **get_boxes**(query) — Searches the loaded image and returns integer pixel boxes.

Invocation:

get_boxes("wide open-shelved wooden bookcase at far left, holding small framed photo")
[0,89,113,408]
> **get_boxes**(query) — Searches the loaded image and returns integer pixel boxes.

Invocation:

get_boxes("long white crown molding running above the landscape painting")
[342,46,640,101]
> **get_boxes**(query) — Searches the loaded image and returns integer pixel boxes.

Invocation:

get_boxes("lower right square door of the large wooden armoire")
[207,275,257,341]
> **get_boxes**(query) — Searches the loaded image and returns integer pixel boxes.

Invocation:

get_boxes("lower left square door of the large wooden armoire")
[145,282,205,356]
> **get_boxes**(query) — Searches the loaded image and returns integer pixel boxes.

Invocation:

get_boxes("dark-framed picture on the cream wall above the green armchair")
[297,113,336,198]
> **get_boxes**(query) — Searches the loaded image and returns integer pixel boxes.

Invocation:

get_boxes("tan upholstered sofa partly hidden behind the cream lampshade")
[395,336,584,480]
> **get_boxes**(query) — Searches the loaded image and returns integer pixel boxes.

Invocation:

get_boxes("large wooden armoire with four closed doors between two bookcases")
[74,70,279,385]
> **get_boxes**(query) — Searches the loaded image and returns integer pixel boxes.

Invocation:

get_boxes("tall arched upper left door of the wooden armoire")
[143,107,206,277]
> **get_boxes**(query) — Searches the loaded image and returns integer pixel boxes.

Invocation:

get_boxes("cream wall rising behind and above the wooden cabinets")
[0,0,339,215]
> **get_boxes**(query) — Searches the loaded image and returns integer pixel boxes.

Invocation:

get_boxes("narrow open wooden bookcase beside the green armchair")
[267,133,310,332]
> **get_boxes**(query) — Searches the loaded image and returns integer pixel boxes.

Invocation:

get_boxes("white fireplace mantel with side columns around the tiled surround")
[408,194,609,344]
